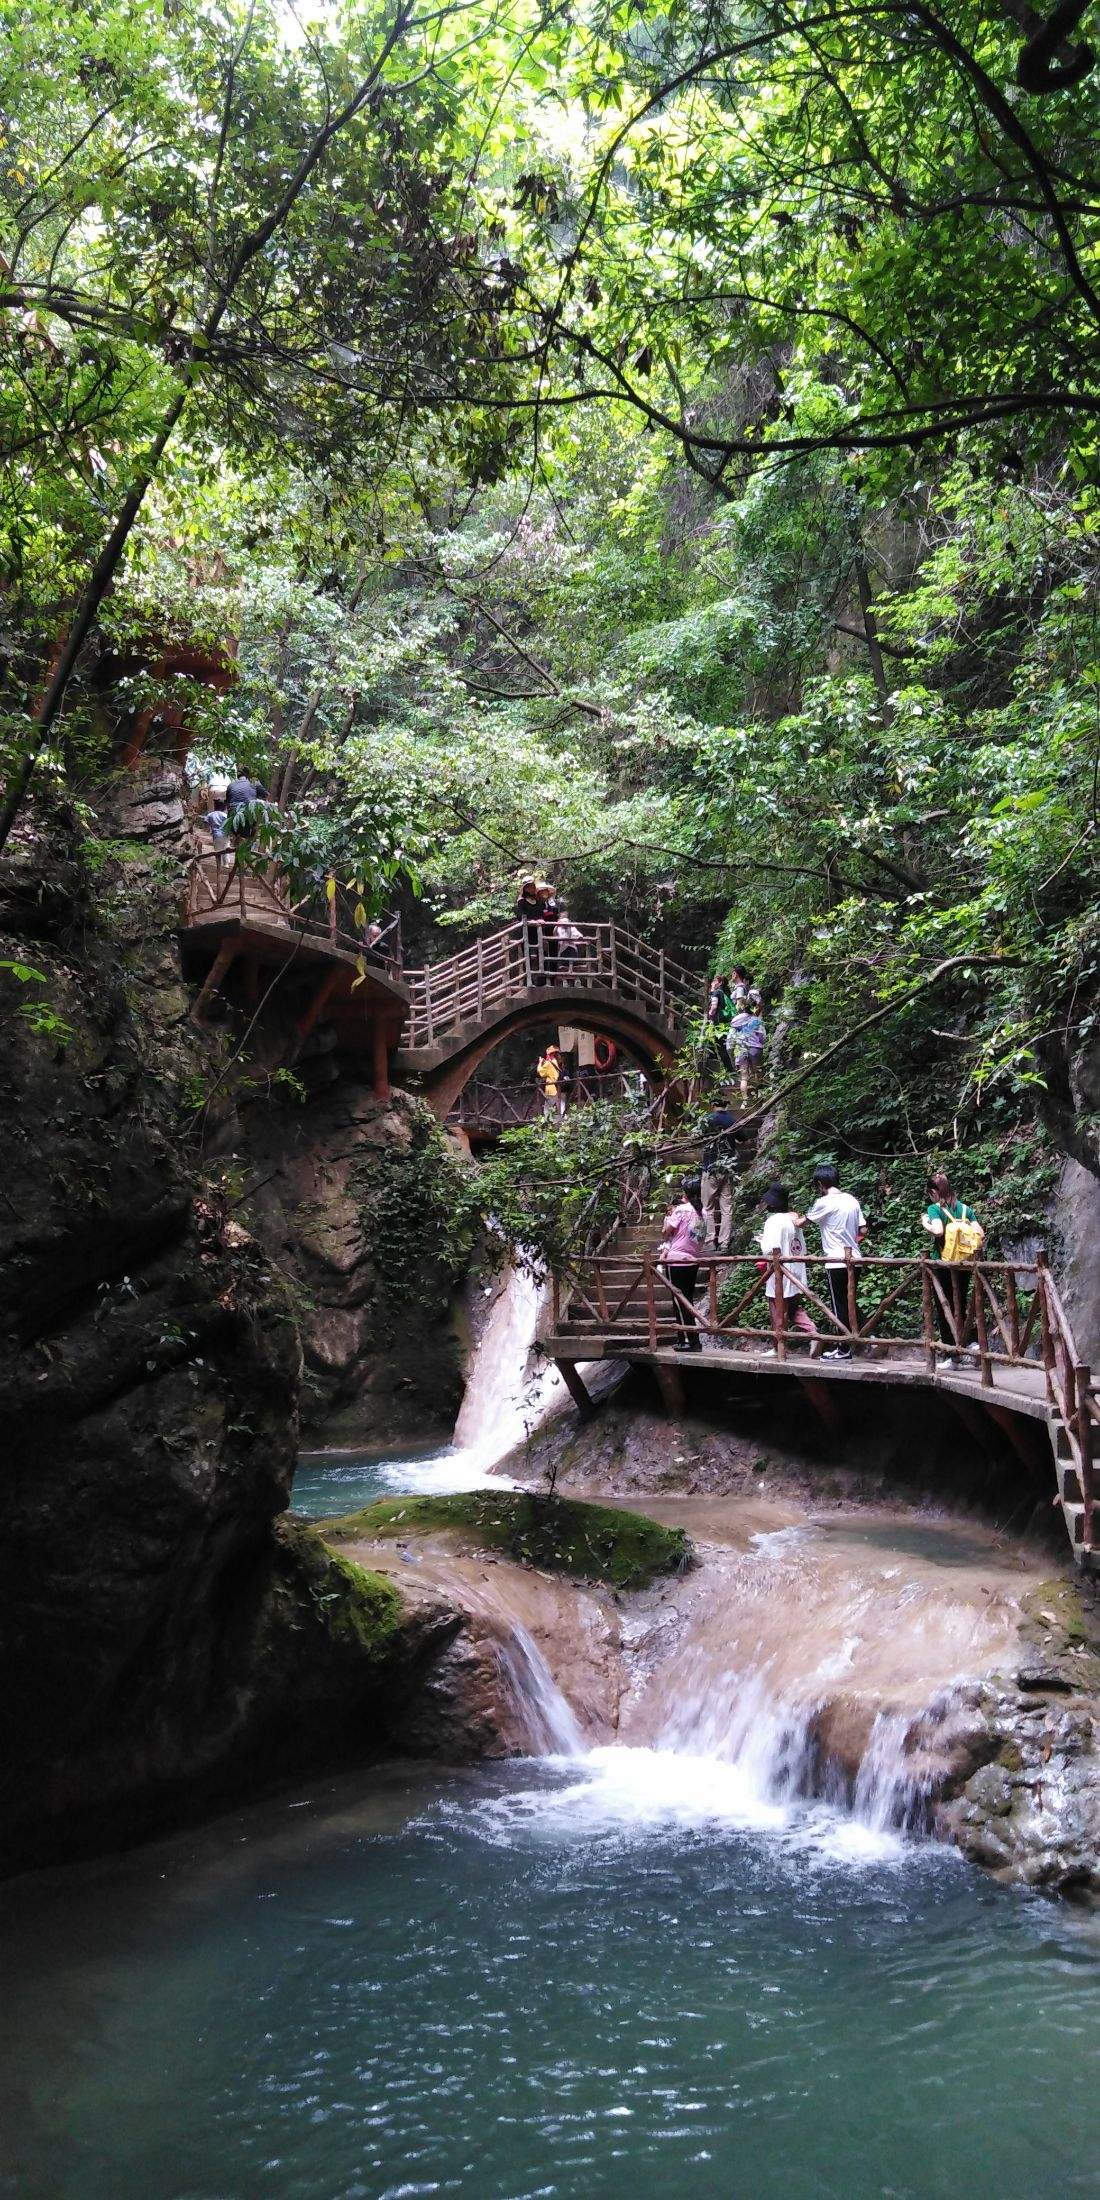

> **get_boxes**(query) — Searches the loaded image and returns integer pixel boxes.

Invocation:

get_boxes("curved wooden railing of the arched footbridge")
[405,924,700,1047]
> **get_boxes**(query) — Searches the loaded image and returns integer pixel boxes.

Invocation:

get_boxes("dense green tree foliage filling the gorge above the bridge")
[0,0,1100,1243]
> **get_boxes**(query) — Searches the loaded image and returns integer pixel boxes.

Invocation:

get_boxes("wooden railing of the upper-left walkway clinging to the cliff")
[185,847,403,977]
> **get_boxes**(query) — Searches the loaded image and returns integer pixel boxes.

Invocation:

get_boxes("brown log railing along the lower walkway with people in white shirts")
[552,1247,1100,1549]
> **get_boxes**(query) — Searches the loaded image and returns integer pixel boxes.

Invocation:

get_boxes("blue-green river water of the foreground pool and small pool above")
[0,1452,1100,2200]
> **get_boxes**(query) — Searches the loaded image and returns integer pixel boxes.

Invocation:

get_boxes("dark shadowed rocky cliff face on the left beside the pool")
[0,777,468,1866]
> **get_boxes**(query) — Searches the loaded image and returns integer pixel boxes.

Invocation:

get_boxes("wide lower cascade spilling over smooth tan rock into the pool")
[475,1527,1029,1859]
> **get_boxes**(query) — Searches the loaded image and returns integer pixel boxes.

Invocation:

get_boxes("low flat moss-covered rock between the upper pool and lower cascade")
[323,1489,695,1588]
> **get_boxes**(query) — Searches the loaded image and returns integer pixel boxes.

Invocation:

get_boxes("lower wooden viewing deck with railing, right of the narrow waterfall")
[541,1258,1100,1566]
